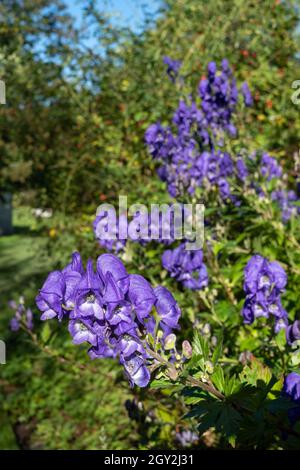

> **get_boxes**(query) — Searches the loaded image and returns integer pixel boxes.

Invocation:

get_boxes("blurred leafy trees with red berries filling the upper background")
[0,0,300,212]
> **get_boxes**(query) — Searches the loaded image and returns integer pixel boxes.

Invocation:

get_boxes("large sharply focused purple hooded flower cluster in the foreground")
[36,253,180,387]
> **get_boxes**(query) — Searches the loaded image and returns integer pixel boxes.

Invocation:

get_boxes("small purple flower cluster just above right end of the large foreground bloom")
[162,243,208,290]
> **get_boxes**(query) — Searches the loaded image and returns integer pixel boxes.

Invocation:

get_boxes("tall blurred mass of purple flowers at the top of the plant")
[145,60,251,200]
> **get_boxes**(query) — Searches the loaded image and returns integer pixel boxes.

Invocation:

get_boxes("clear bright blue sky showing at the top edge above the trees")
[64,0,160,31]
